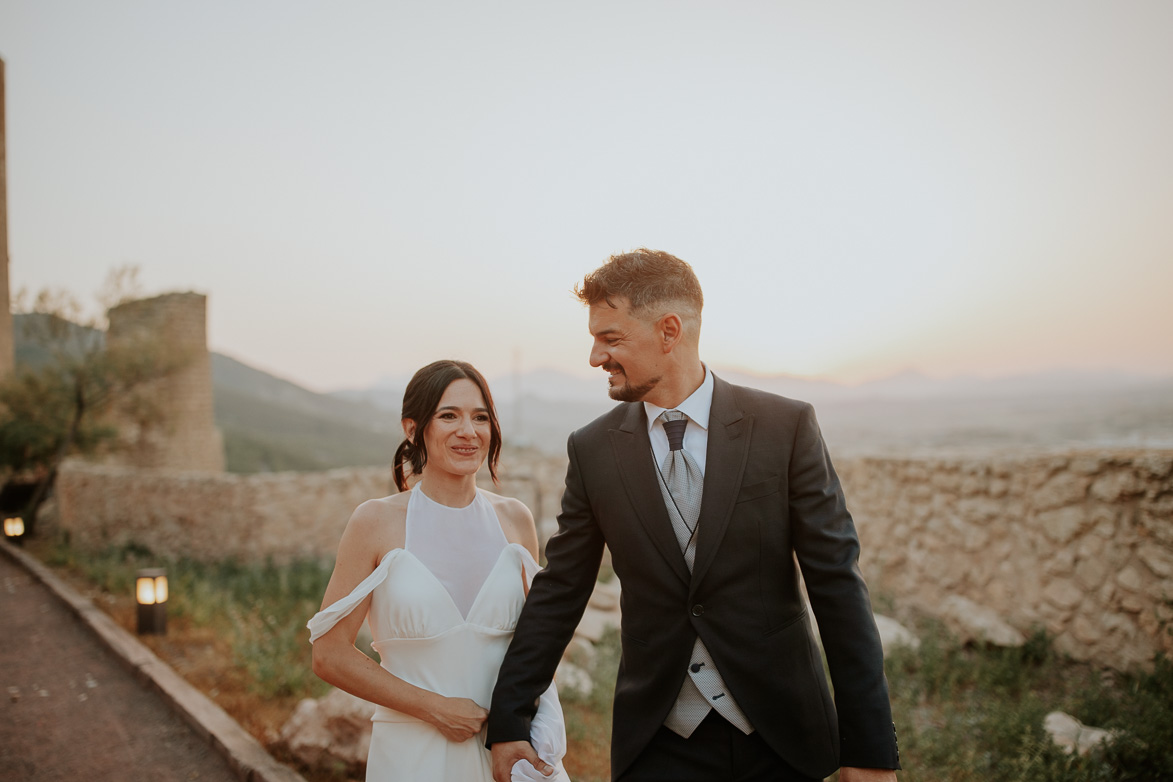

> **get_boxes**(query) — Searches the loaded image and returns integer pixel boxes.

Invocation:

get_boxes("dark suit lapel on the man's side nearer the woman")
[610,402,689,584]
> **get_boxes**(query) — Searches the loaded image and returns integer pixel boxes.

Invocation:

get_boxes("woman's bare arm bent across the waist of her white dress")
[313,501,488,742]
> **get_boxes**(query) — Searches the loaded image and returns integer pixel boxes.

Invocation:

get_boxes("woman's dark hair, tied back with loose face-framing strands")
[392,359,501,491]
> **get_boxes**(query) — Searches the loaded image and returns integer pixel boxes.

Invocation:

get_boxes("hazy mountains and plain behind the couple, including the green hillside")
[15,315,1173,472]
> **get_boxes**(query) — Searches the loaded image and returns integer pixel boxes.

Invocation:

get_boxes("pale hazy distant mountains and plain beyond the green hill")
[332,368,1173,454]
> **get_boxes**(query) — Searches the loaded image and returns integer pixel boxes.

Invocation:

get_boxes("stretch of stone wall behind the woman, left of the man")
[55,449,564,560]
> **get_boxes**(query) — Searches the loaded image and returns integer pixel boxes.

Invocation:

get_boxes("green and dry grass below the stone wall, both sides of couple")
[30,540,1173,782]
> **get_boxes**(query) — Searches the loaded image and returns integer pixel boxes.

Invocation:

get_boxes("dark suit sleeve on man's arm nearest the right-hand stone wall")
[788,404,900,768]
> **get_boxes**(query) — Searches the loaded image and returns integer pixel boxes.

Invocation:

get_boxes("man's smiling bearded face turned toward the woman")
[588,298,664,402]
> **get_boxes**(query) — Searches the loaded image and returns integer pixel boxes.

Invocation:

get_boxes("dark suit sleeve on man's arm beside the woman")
[486,435,604,747]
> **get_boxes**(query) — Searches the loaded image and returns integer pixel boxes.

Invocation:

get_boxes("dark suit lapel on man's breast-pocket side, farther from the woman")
[689,375,753,594]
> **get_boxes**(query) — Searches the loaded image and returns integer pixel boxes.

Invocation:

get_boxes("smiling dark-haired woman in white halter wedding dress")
[308,361,569,782]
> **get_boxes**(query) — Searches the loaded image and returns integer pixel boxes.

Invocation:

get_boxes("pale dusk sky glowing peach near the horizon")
[0,0,1173,390]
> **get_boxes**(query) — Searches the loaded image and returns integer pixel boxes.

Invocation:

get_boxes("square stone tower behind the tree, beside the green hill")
[106,293,224,471]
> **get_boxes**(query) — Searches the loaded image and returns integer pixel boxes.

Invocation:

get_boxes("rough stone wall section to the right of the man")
[839,450,1173,668]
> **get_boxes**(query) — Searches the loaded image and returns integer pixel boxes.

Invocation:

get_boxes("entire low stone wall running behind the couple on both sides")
[50,450,1173,668]
